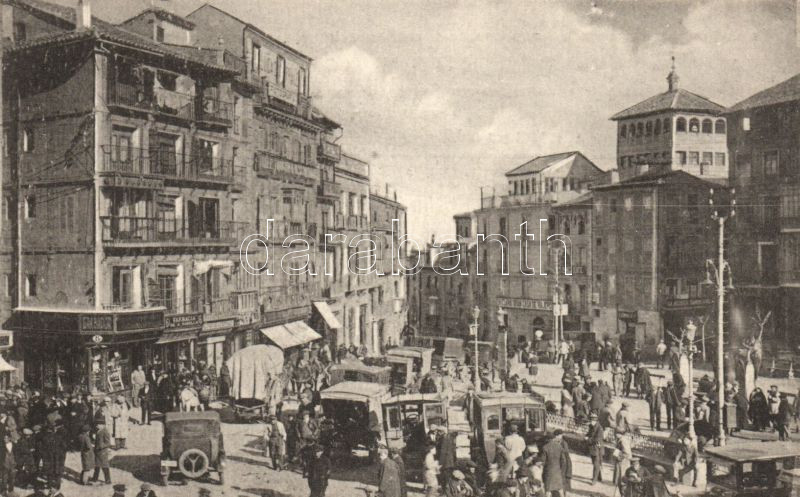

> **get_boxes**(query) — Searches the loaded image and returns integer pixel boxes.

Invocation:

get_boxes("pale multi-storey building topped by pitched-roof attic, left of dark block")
[474,152,607,346]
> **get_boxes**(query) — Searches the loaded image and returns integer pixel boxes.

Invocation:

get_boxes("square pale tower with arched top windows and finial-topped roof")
[611,66,728,180]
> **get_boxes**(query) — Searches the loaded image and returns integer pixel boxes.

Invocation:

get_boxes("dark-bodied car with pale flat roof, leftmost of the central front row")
[320,381,391,461]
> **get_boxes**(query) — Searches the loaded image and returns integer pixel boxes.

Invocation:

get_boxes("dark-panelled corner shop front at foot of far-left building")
[11,308,164,395]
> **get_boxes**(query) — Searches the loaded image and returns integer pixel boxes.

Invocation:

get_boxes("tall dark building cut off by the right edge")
[726,72,800,349]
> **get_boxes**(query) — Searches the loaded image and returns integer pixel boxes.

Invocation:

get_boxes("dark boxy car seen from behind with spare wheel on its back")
[161,411,225,485]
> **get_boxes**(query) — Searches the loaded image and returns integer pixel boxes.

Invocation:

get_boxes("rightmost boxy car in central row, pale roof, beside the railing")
[470,392,547,468]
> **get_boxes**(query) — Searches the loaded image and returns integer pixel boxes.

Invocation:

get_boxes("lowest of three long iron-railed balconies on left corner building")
[100,216,248,247]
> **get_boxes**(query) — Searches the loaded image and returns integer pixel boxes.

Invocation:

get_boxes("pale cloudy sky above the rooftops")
[58,0,800,240]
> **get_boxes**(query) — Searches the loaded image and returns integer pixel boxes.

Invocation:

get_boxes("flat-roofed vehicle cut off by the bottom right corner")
[704,442,800,497]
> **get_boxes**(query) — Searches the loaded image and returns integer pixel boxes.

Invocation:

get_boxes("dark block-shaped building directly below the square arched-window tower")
[592,171,721,354]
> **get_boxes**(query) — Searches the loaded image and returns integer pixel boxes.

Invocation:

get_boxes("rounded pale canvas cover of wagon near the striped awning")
[226,345,283,401]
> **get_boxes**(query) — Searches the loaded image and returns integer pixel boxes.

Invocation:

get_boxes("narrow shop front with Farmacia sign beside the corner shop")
[152,312,203,371]
